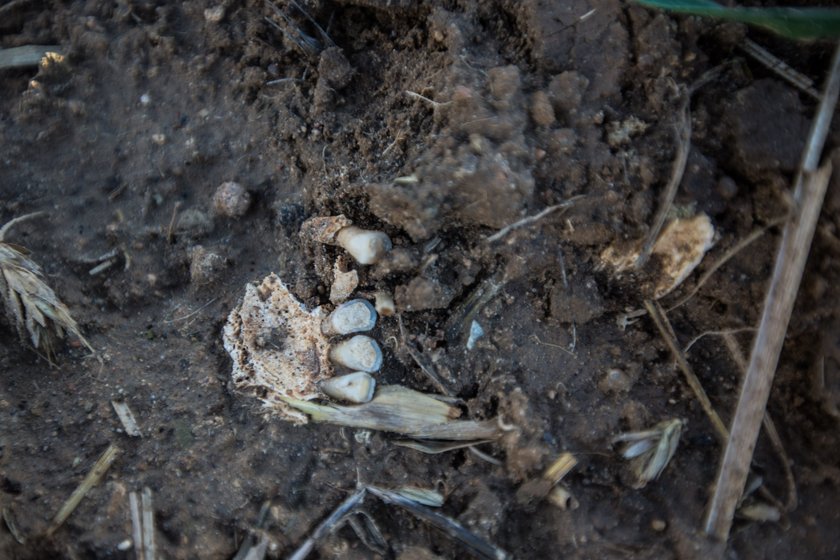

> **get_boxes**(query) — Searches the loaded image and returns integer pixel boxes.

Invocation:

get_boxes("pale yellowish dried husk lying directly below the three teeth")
[280,385,500,441]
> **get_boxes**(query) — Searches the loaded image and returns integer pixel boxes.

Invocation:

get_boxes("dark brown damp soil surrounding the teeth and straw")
[0,0,840,559]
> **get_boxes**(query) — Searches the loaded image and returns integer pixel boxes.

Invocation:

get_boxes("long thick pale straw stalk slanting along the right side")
[706,41,840,540]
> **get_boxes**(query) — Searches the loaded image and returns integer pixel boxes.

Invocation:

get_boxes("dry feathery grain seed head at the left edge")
[0,213,93,359]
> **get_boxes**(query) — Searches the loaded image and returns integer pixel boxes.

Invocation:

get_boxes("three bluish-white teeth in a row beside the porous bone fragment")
[320,299,382,404]
